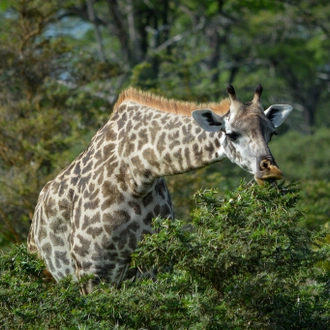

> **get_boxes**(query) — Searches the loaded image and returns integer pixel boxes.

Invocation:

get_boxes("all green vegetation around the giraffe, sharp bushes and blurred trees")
[0,0,330,329]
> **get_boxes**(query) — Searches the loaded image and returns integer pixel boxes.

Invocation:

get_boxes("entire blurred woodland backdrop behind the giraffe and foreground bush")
[0,0,330,245]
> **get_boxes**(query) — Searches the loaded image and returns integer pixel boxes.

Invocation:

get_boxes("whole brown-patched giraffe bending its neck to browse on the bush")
[28,85,292,294]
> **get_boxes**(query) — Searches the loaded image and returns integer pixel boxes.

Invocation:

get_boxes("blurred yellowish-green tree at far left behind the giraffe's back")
[0,0,118,244]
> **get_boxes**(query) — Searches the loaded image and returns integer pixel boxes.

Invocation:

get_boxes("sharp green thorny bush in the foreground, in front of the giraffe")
[0,183,330,329]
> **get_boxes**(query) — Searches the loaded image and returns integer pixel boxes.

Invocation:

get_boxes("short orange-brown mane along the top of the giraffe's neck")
[114,87,230,116]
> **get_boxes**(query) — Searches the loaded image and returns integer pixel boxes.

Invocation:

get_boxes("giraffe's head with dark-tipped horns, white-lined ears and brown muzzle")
[192,85,292,184]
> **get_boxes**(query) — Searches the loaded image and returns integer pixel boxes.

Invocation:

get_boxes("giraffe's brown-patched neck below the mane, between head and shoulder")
[110,102,225,193]
